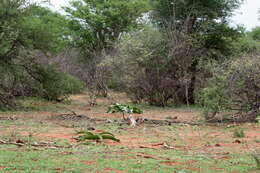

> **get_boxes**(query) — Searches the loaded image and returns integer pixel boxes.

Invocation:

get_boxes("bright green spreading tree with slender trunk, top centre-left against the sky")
[64,0,149,98]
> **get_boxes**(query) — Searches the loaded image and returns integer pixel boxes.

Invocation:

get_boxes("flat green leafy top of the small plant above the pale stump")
[107,103,143,114]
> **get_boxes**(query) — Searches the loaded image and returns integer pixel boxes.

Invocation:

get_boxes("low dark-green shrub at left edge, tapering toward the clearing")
[0,62,84,110]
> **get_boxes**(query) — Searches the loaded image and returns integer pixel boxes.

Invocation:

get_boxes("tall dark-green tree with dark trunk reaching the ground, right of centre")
[151,0,242,104]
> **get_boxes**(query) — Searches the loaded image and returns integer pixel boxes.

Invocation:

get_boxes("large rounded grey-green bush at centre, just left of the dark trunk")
[102,26,192,107]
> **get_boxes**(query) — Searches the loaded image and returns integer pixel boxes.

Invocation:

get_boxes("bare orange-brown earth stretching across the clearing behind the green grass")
[0,94,260,172]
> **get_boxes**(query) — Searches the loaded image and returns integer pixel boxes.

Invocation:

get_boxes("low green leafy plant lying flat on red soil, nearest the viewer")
[76,131,120,142]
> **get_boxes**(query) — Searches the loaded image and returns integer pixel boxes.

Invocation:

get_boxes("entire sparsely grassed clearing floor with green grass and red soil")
[0,92,260,173]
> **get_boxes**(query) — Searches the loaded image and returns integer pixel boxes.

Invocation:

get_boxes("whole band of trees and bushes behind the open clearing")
[0,0,260,121]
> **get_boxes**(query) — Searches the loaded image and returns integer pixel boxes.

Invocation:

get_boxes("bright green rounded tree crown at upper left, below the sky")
[21,6,70,53]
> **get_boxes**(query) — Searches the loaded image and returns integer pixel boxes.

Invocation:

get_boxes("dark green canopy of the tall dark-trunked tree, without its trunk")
[151,0,242,55]
